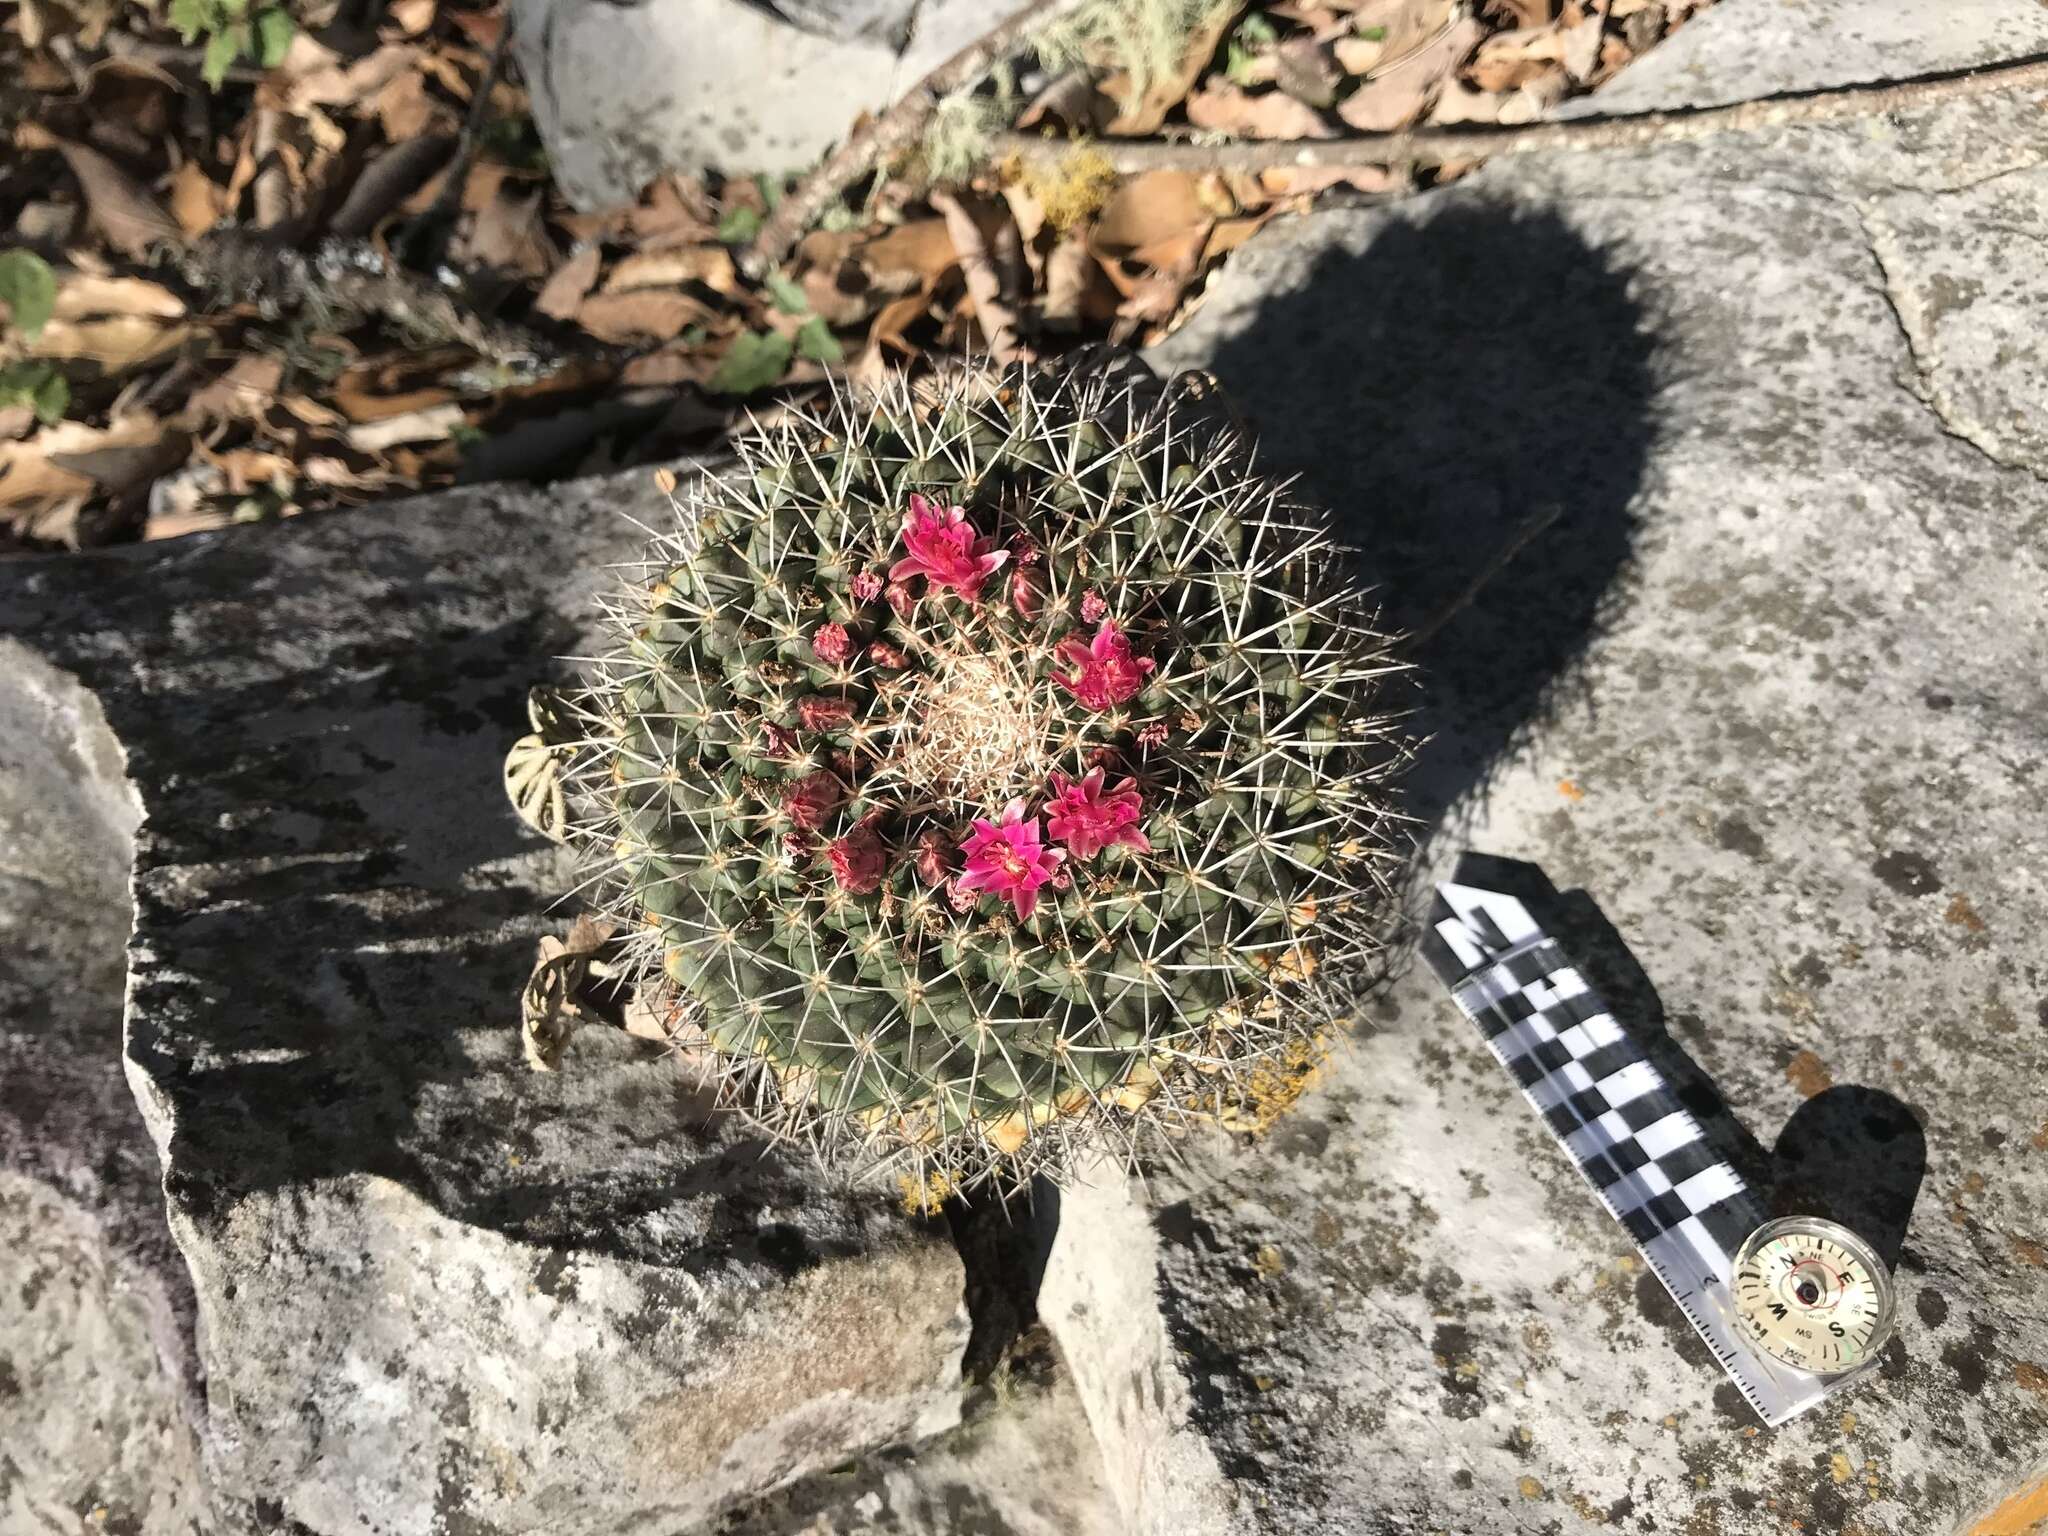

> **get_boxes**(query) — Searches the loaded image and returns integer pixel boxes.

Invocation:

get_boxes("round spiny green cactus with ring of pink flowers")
[544,369,1401,1188]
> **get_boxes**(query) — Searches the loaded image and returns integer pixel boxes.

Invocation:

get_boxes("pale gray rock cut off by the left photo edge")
[0,641,203,1536]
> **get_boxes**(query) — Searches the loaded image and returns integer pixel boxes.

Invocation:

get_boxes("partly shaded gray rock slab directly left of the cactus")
[0,477,967,1536]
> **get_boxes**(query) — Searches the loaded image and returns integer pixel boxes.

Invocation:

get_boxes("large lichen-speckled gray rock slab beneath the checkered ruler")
[1042,81,2048,1536]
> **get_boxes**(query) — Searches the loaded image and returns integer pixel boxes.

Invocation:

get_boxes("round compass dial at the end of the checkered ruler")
[1735,1217,1892,1376]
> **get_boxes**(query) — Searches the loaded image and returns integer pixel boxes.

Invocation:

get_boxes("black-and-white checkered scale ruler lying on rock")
[1423,885,1831,1425]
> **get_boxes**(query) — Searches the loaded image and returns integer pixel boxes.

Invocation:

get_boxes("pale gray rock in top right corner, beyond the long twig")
[1554,0,2048,117]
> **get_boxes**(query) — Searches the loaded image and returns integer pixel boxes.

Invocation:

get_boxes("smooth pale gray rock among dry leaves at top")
[512,0,991,209]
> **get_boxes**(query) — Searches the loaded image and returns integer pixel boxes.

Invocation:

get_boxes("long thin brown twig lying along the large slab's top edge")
[991,57,2048,174]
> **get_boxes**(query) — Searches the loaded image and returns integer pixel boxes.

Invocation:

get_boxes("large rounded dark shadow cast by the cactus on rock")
[1210,205,1655,843]
